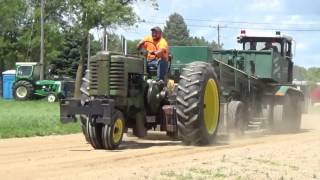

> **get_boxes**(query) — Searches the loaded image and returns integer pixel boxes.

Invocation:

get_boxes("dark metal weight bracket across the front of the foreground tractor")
[60,98,115,124]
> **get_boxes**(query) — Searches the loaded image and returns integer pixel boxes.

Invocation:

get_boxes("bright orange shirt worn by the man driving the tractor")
[143,35,169,60]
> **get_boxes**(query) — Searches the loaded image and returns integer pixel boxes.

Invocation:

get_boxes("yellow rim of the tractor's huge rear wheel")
[203,79,220,134]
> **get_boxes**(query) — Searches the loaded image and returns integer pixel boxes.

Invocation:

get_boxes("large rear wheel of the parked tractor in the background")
[13,80,34,101]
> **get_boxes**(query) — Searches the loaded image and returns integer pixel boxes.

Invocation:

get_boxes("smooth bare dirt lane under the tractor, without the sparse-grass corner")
[0,115,320,179]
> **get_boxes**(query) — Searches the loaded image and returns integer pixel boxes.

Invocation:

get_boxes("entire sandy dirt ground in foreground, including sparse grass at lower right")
[0,114,320,180]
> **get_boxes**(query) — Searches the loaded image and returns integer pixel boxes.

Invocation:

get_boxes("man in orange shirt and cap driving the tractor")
[137,26,169,81]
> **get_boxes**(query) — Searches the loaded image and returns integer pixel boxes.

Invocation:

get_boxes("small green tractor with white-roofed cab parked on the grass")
[13,62,63,102]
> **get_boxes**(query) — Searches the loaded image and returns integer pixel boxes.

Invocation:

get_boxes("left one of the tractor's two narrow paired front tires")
[86,118,103,149]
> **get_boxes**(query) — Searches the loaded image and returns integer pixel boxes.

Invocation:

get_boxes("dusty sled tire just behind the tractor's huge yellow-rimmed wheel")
[228,101,247,135]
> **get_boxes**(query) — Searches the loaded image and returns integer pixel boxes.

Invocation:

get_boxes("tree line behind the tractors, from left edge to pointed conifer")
[0,0,221,95]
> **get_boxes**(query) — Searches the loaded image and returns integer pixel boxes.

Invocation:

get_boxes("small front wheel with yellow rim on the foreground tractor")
[102,111,125,150]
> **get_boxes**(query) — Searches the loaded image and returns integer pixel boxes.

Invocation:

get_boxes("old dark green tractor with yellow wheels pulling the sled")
[60,51,220,150]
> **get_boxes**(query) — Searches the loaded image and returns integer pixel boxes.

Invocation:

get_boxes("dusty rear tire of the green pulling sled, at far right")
[272,95,302,133]
